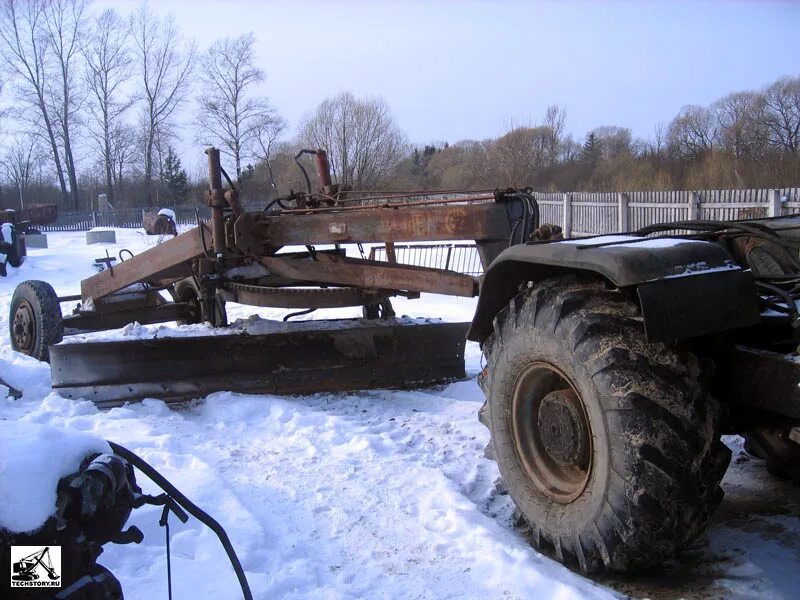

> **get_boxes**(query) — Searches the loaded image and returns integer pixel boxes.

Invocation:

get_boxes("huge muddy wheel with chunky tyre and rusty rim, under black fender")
[481,276,730,572]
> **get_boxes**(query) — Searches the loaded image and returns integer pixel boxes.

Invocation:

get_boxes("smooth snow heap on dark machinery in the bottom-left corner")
[0,421,111,532]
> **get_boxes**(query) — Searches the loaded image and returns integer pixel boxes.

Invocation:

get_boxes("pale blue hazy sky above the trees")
[94,0,800,162]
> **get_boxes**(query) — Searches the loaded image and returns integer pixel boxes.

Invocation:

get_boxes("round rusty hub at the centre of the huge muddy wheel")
[538,389,587,467]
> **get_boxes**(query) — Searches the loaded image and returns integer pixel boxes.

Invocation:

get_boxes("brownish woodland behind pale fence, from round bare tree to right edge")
[264,77,800,197]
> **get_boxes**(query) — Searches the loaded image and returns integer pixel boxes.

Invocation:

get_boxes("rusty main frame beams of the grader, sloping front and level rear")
[81,192,511,302]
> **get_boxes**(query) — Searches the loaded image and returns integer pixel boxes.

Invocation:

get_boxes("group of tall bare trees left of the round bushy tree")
[0,0,285,210]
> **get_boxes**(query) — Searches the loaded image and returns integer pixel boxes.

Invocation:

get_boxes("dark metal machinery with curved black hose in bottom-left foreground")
[0,442,252,600]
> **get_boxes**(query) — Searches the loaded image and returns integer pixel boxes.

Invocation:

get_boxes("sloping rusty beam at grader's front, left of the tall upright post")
[81,224,206,301]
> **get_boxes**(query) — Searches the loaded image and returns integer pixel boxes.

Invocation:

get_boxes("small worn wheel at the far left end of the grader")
[8,281,64,362]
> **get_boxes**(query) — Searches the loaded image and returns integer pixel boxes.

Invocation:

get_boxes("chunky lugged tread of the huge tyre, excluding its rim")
[482,276,730,572]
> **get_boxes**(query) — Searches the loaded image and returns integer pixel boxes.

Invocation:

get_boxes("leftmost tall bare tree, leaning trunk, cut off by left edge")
[0,0,69,203]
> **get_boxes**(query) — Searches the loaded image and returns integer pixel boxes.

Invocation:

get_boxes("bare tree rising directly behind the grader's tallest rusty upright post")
[198,33,282,178]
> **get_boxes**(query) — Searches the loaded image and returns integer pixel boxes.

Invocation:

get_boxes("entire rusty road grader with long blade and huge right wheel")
[10,149,800,572]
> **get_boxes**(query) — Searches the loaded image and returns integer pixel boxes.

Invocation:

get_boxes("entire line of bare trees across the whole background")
[0,0,800,211]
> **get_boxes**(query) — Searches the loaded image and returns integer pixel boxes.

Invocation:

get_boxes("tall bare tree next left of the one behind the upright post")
[131,4,195,202]
